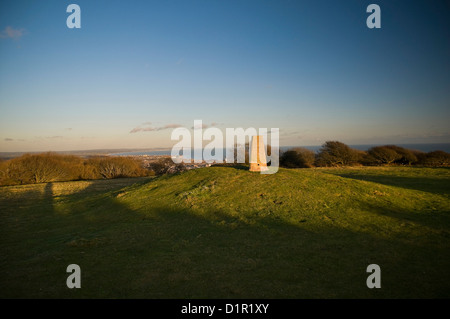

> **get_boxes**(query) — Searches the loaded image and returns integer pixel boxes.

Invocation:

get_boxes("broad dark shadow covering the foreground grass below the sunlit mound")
[1,176,450,298]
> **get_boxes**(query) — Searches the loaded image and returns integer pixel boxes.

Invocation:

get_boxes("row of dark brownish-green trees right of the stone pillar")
[280,141,450,168]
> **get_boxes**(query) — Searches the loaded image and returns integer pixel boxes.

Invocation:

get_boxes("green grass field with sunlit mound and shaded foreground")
[0,167,450,298]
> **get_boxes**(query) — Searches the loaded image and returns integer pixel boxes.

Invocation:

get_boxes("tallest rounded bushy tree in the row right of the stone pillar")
[316,141,359,166]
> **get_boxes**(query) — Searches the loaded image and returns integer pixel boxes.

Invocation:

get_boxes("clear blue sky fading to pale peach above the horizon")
[0,0,450,152]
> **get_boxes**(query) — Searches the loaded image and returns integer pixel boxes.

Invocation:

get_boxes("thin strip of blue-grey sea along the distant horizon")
[110,143,450,158]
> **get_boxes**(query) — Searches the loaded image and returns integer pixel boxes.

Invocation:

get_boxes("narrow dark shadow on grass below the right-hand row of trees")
[334,173,450,195]
